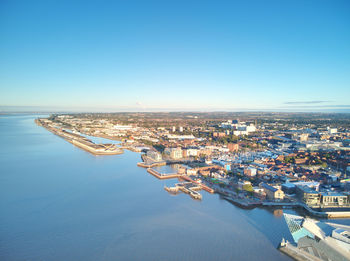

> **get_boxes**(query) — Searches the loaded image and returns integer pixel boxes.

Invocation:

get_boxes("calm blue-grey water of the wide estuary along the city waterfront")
[0,115,340,261]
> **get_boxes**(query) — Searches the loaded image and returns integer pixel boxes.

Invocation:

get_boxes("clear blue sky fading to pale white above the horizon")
[0,0,350,111]
